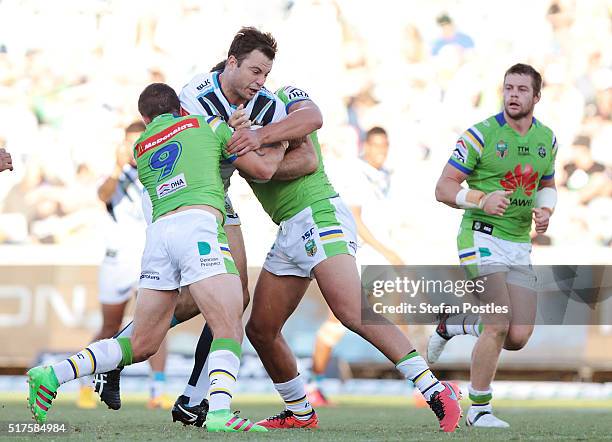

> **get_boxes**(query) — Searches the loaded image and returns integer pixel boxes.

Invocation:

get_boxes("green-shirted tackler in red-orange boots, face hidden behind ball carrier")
[241,87,460,432]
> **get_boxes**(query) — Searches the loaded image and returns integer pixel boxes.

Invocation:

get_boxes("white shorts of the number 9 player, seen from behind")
[139,209,238,290]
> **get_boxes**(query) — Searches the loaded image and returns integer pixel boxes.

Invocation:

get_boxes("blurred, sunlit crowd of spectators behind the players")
[0,0,612,265]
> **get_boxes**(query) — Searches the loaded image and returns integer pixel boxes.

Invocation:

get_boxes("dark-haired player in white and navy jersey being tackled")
[89,28,322,426]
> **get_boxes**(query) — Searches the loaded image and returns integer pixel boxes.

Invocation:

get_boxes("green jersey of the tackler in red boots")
[249,86,337,224]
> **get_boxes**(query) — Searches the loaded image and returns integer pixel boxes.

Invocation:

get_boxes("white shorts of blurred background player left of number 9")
[98,249,142,304]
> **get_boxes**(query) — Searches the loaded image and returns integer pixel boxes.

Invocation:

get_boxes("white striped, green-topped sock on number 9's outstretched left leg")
[51,338,133,384]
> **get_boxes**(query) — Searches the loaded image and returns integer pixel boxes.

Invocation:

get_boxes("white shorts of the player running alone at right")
[457,228,536,289]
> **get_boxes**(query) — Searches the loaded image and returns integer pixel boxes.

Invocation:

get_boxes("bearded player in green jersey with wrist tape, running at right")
[428,64,557,428]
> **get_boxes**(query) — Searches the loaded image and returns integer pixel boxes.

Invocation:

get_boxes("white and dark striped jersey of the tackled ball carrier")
[179,72,287,192]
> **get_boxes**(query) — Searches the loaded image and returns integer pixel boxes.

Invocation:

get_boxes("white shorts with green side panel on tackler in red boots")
[264,197,357,278]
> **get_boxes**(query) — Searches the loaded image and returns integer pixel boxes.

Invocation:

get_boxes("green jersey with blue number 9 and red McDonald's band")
[134,114,236,222]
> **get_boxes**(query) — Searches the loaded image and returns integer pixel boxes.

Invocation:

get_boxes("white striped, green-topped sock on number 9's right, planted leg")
[208,338,242,411]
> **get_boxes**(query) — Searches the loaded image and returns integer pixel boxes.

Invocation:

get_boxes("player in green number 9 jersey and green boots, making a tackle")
[28,83,284,432]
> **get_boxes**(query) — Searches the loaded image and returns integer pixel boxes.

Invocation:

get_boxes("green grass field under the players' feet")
[0,394,612,442]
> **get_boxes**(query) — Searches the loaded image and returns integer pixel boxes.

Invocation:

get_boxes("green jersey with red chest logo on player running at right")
[448,112,557,242]
